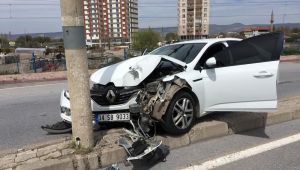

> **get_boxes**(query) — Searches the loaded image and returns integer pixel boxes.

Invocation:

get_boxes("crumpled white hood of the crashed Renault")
[90,55,186,87]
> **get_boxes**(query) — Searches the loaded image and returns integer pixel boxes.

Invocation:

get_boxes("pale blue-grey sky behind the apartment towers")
[0,0,300,34]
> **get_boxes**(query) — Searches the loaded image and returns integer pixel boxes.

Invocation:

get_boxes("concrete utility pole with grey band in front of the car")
[60,0,94,148]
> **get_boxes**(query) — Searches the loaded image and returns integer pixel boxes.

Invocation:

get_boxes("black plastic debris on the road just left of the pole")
[41,121,72,134]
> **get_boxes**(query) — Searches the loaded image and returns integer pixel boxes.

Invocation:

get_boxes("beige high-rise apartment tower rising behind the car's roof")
[178,0,209,40]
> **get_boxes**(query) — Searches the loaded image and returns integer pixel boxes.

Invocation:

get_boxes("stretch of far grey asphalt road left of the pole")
[0,82,66,150]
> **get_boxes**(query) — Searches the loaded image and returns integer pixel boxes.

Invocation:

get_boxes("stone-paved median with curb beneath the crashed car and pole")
[0,97,300,170]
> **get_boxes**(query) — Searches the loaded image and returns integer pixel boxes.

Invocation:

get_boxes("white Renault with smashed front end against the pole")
[61,33,283,134]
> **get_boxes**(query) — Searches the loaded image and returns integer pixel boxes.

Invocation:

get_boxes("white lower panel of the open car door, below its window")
[202,61,279,112]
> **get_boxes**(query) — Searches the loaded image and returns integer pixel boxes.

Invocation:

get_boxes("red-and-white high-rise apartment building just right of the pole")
[83,0,138,45]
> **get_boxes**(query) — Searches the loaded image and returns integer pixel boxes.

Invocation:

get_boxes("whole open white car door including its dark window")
[203,33,283,112]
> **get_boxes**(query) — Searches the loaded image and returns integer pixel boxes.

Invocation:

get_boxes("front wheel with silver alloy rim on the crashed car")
[162,91,196,135]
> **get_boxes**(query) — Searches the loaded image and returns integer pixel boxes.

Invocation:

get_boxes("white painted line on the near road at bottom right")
[184,133,300,170]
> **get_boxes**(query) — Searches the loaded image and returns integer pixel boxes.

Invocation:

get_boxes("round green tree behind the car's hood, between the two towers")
[132,29,160,52]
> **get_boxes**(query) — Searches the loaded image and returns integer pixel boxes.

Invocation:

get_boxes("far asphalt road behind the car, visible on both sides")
[0,63,300,150]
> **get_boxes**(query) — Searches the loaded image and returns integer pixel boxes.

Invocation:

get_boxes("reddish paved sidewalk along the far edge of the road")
[0,55,300,84]
